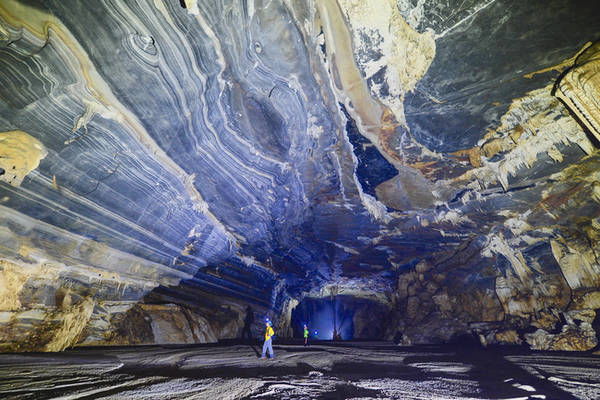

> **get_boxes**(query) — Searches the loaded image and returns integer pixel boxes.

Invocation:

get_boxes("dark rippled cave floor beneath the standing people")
[0,342,600,400]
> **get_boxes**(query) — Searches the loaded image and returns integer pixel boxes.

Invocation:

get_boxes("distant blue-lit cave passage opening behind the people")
[291,295,389,340]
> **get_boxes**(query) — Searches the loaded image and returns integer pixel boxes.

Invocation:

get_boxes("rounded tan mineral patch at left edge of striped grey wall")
[0,131,48,186]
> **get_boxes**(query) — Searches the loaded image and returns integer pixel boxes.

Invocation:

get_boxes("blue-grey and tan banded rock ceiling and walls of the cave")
[0,0,600,351]
